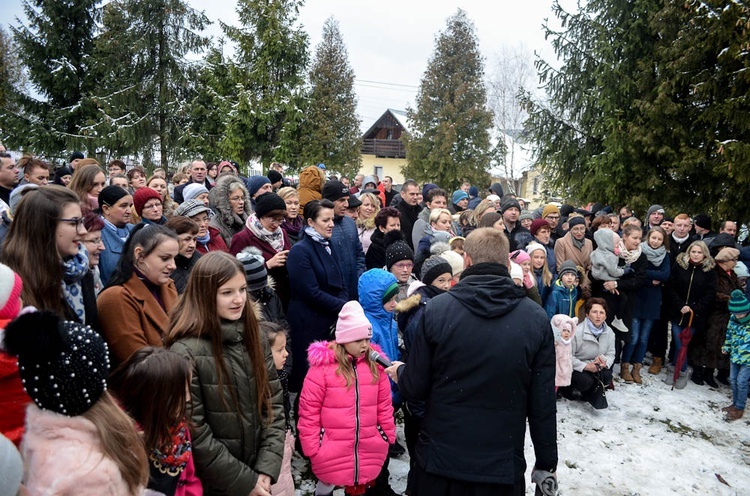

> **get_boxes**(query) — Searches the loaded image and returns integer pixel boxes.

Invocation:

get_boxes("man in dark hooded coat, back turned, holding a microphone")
[387,228,557,496]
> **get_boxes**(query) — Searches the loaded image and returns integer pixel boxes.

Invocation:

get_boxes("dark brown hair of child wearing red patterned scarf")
[107,346,191,453]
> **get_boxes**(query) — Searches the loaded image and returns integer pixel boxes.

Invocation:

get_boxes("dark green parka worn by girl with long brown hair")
[171,320,285,496]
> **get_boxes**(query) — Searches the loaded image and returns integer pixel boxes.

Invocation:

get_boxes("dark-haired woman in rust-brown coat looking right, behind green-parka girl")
[97,224,179,364]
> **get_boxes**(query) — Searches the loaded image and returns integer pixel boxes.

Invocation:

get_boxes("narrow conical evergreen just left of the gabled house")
[298,17,362,177]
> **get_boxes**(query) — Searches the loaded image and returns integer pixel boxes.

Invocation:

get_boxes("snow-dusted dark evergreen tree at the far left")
[4,0,100,155]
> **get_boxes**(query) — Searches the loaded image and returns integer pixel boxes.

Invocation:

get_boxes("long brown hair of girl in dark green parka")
[167,251,273,424]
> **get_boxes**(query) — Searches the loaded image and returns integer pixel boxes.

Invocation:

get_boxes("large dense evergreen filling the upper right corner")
[526,0,750,219]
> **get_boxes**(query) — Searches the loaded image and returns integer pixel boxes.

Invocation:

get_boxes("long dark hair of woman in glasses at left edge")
[0,185,79,317]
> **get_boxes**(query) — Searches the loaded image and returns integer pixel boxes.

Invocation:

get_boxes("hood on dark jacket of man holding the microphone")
[450,263,526,318]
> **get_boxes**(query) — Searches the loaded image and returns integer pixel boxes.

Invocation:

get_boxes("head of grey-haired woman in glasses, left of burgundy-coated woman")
[208,175,252,247]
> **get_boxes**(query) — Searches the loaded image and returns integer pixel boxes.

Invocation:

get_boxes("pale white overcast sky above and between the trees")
[2,0,567,129]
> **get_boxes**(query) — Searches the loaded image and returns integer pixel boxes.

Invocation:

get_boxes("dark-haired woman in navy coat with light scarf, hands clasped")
[287,200,348,392]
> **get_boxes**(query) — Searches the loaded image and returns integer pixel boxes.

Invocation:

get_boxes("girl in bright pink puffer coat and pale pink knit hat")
[297,301,396,495]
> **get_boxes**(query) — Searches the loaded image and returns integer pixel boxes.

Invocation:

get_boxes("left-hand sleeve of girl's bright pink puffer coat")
[297,367,326,458]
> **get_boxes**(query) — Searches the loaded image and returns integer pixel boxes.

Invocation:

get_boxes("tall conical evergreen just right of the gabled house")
[404,9,494,189]
